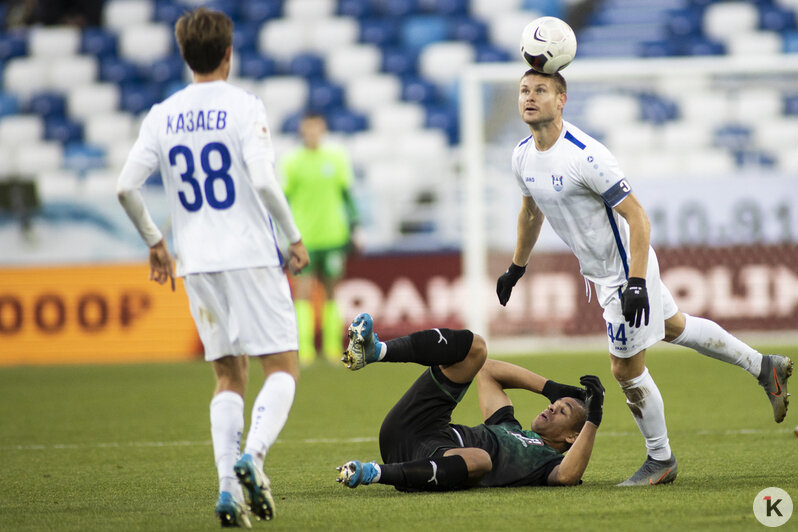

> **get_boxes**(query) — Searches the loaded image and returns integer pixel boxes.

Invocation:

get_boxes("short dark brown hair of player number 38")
[175,7,233,74]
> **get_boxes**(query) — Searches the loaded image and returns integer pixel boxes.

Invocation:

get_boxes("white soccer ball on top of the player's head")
[521,17,576,74]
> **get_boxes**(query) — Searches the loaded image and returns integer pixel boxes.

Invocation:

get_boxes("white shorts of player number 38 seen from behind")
[185,267,297,361]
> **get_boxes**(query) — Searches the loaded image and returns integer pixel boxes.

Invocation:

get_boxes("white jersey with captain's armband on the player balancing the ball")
[512,121,631,286]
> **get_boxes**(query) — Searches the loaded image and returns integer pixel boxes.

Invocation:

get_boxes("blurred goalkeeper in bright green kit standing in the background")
[280,113,357,366]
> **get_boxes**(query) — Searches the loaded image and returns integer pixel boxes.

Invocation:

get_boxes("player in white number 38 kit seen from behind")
[117,8,308,527]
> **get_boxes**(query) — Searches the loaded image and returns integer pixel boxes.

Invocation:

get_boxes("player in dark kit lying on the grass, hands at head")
[338,314,604,491]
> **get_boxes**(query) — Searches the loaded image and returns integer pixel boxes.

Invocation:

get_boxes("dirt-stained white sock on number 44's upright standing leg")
[619,368,671,460]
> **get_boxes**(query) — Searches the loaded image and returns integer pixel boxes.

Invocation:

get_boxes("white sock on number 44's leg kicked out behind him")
[671,314,762,378]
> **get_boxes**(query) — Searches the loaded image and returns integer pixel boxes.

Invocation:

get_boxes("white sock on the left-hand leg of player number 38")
[211,391,244,501]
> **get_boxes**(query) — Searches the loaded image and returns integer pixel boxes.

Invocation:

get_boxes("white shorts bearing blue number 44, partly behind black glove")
[596,248,679,358]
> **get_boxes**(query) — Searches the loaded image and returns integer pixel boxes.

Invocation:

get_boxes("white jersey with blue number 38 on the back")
[128,81,281,276]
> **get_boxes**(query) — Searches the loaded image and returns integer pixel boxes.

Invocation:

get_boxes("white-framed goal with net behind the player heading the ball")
[460,56,798,350]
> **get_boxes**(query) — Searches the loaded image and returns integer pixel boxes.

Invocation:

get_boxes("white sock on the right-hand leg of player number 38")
[244,371,296,468]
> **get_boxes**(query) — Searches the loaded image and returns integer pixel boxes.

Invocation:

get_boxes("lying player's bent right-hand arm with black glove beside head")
[548,375,604,486]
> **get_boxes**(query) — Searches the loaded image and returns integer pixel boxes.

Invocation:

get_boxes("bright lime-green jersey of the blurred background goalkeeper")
[280,145,352,250]
